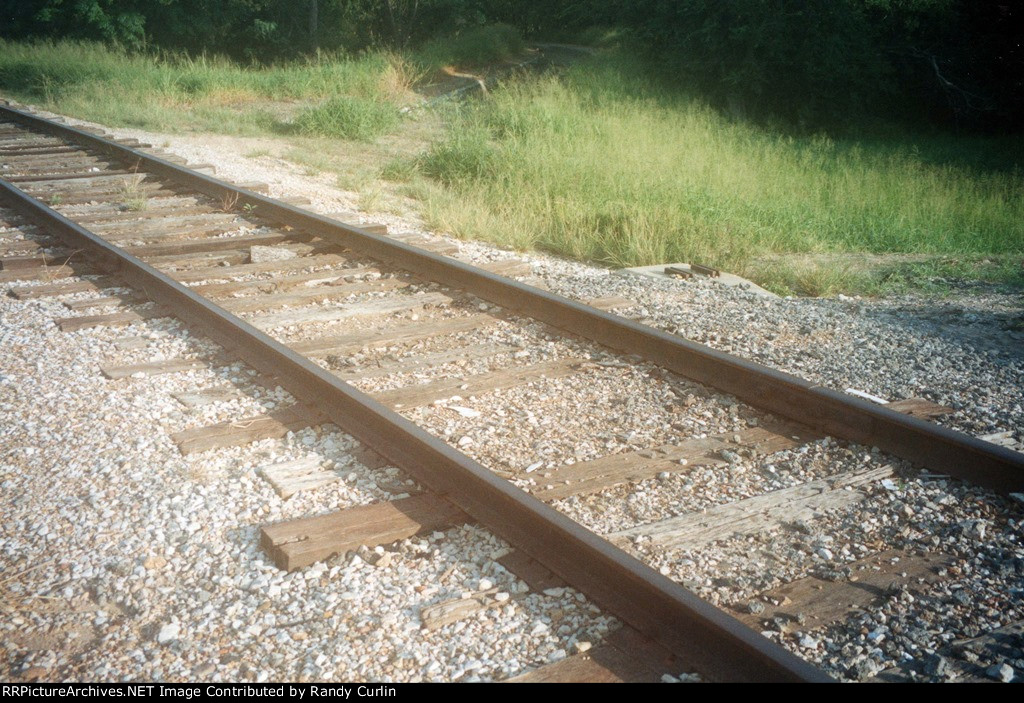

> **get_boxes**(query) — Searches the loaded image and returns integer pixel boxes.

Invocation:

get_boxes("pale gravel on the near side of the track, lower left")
[0,290,613,682]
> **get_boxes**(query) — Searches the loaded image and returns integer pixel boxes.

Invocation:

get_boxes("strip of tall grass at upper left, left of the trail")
[0,41,414,134]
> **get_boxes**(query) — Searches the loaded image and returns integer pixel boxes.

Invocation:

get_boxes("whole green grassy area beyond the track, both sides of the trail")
[0,40,1024,295]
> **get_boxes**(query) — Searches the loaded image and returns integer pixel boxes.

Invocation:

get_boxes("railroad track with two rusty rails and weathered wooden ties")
[0,101,1024,680]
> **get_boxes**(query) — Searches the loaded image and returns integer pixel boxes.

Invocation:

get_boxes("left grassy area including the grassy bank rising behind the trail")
[0,25,523,140]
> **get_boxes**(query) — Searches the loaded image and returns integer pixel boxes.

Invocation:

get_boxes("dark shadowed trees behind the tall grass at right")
[609,0,1024,130]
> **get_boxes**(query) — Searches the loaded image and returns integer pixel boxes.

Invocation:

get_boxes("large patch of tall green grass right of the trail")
[417,55,1024,282]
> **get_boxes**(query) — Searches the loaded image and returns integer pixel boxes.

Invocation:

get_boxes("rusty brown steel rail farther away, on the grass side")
[0,104,1024,492]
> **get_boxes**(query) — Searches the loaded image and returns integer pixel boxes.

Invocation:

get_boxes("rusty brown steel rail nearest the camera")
[0,171,831,683]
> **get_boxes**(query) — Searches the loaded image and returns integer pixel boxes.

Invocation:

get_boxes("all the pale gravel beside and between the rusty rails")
[0,107,1024,680]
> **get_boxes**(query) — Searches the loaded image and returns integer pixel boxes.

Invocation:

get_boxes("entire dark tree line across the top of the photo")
[0,0,1024,131]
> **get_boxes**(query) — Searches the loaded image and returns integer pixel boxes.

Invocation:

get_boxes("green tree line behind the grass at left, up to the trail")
[0,0,557,55]
